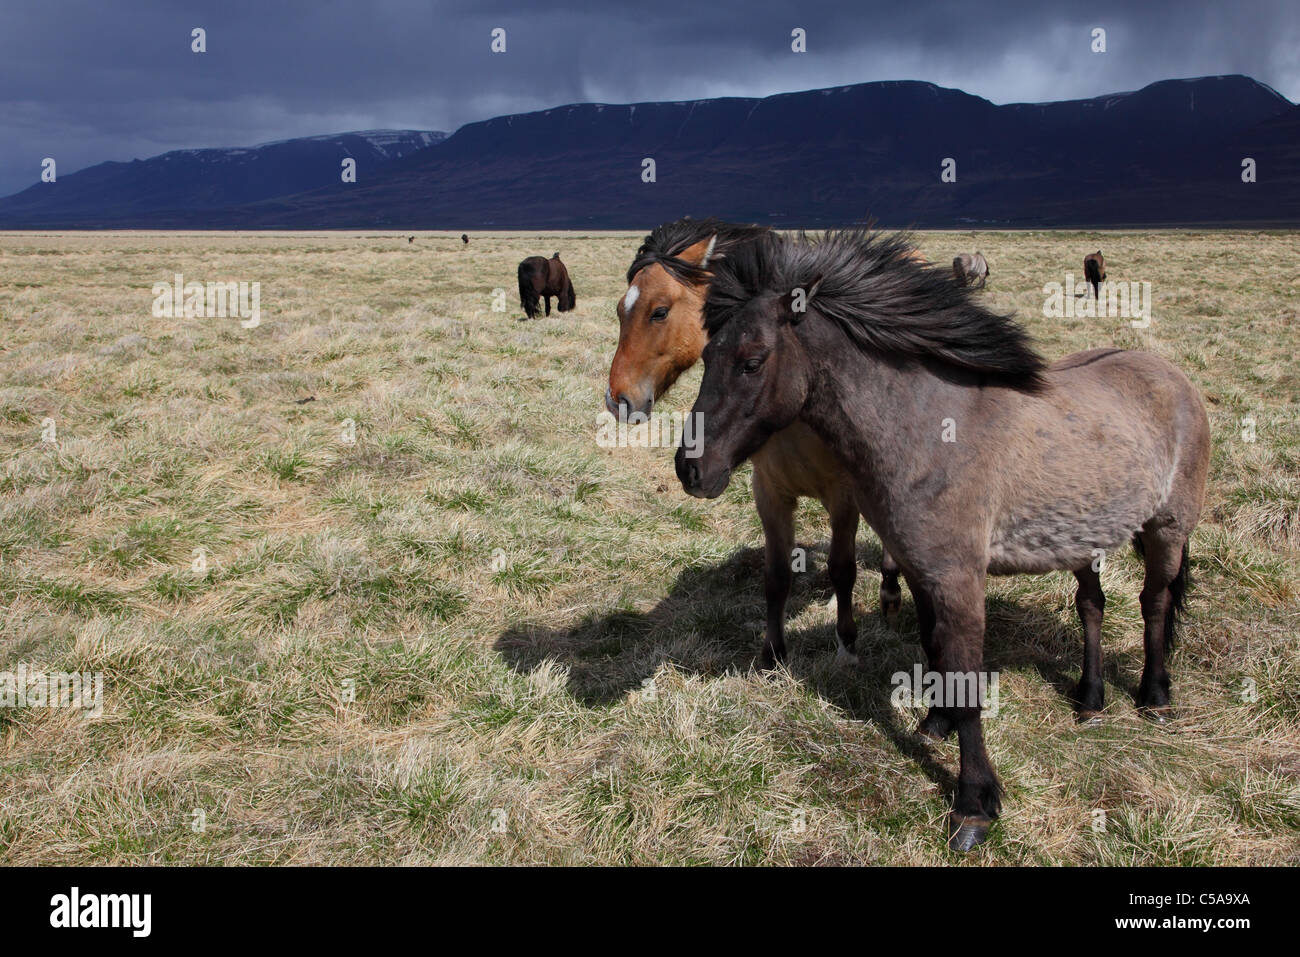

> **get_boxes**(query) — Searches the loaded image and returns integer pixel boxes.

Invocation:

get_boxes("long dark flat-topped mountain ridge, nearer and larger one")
[0,74,1300,229]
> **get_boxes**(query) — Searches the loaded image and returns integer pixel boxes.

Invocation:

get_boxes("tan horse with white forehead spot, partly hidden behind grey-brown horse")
[605,217,902,668]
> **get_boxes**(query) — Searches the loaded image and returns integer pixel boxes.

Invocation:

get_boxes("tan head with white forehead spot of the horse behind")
[605,237,715,415]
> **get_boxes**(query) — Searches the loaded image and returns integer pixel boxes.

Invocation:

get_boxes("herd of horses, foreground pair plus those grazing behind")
[519,218,1210,852]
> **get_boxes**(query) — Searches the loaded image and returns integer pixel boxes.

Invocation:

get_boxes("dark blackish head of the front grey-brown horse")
[676,257,820,498]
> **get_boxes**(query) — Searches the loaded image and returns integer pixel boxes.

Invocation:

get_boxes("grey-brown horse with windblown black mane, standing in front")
[676,231,1210,850]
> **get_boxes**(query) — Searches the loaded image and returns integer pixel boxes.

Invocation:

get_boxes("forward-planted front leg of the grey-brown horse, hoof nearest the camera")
[927,564,1002,852]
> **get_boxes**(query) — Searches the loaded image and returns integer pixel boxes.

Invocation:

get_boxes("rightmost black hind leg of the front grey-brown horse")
[1138,527,1187,724]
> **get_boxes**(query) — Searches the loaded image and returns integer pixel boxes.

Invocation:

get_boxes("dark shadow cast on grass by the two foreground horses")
[494,544,1135,792]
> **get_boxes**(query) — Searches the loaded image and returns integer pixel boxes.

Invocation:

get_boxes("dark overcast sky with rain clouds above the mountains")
[0,0,1300,195]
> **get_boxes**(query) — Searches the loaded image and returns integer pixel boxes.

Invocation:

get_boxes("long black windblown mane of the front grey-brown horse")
[705,229,1047,391]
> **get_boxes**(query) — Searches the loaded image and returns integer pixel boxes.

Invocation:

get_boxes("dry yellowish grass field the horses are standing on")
[0,233,1300,865]
